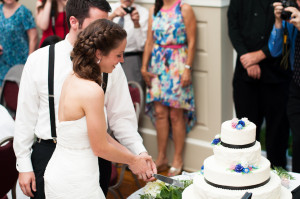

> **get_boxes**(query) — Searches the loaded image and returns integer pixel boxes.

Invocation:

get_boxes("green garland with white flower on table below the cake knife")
[140,180,193,199]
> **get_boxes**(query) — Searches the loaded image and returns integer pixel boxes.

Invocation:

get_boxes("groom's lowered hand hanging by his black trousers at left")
[19,171,36,197]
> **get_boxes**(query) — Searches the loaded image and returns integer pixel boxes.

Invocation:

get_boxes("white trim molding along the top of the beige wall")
[109,0,230,7]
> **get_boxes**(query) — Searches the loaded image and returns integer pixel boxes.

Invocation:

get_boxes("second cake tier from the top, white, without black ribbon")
[213,141,261,167]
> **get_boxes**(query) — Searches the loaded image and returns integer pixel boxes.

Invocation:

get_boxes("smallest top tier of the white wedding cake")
[221,121,256,145]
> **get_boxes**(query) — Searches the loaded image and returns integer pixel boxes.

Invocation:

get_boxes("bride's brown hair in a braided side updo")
[71,19,127,85]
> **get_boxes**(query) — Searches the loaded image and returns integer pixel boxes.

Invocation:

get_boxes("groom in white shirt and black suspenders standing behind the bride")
[14,0,156,199]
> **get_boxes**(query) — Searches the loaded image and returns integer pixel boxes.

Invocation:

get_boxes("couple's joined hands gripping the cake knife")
[129,154,153,180]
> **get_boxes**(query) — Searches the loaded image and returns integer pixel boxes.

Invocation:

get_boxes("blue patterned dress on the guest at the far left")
[0,4,36,86]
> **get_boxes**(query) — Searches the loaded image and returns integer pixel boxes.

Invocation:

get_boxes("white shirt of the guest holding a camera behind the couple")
[110,3,149,52]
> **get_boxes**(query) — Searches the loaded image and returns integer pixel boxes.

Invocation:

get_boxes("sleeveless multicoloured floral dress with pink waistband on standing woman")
[146,0,196,132]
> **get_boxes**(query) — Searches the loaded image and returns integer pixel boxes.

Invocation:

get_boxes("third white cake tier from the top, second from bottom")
[204,156,270,187]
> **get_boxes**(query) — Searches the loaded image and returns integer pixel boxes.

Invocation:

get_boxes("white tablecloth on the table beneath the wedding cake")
[127,172,300,199]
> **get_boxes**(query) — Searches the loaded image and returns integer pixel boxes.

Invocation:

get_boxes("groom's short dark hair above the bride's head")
[66,0,111,29]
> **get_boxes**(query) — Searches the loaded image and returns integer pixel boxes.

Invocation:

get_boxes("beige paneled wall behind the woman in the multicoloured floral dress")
[20,0,233,171]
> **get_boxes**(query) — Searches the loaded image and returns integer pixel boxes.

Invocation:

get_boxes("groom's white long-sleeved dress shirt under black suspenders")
[14,36,146,172]
